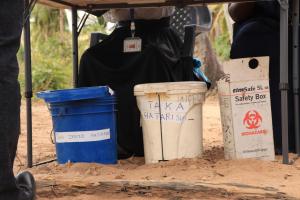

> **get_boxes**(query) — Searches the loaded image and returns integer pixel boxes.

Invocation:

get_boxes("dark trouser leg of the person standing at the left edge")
[0,0,24,200]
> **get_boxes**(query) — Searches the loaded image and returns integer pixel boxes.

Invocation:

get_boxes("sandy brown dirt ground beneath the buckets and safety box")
[15,97,300,200]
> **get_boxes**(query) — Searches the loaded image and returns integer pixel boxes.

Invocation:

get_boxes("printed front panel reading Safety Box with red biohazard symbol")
[231,80,273,158]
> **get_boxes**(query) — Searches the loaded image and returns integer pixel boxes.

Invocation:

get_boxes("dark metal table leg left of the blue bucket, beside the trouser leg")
[24,0,32,168]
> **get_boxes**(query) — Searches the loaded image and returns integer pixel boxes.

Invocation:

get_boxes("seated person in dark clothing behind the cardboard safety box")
[228,0,295,154]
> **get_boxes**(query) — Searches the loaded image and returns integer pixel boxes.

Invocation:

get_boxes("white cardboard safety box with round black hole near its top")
[218,57,275,160]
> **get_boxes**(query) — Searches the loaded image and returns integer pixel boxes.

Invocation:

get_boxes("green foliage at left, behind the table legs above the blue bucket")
[18,5,104,93]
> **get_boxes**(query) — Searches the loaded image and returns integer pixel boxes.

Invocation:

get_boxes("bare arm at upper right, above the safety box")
[228,2,255,22]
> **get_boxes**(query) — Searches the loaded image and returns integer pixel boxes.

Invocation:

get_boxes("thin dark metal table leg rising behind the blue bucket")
[72,7,78,87]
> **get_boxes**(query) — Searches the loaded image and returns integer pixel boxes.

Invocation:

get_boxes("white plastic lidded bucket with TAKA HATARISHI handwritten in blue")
[134,82,207,164]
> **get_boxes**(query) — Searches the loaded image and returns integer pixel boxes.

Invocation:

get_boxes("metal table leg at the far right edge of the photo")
[293,0,300,156]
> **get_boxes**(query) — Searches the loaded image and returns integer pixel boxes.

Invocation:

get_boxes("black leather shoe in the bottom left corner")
[16,172,36,200]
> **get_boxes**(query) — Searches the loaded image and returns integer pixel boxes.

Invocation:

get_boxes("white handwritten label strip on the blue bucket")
[55,129,110,143]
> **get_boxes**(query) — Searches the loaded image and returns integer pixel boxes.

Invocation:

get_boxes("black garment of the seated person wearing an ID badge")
[79,18,193,156]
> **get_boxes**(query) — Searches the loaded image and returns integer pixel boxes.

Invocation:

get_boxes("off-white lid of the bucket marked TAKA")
[134,81,207,96]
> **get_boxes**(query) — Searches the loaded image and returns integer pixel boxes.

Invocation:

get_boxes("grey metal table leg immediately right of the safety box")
[279,0,289,164]
